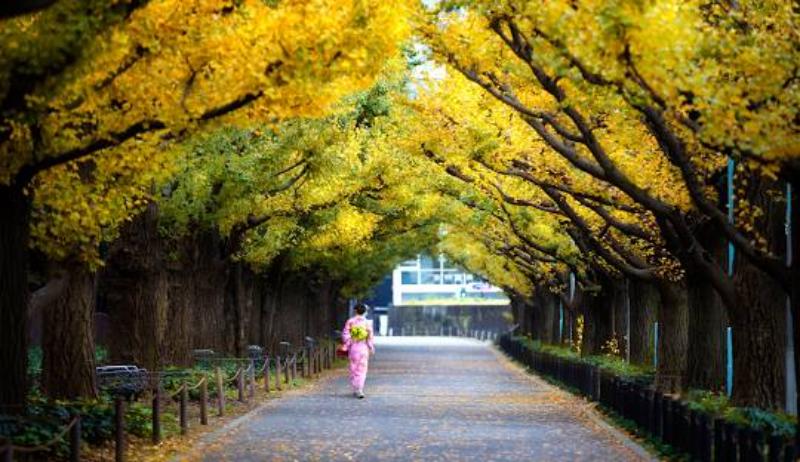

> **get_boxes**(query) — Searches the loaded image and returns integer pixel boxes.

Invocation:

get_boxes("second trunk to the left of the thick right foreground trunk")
[656,281,689,393]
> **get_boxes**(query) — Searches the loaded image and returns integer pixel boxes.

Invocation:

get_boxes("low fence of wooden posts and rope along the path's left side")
[0,339,336,462]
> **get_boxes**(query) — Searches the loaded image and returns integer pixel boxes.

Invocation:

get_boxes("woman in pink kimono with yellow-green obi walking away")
[342,303,375,399]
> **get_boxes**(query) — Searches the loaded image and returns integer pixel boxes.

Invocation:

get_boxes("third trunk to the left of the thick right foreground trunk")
[629,280,661,366]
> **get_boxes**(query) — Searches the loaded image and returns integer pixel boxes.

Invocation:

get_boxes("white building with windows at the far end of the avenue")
[392,255,509,306]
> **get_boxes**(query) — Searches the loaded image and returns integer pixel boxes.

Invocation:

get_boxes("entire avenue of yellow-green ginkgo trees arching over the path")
[0,0,800,430]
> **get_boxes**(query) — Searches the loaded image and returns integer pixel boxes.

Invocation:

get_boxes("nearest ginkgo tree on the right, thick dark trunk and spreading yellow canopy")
[420,1,797,407]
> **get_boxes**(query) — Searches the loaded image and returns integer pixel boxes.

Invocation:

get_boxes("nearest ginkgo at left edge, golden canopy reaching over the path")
[0,0,410,412]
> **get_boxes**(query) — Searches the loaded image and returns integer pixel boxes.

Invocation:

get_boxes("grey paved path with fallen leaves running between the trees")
[182,337,648,462]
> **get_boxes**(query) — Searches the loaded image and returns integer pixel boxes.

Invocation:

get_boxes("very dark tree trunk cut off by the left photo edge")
[0,185,31,414]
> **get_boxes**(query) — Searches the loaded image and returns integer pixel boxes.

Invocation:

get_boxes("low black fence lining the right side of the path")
[499,335,798,462]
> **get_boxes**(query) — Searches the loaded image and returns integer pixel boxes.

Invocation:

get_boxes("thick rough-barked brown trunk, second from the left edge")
[42,263,97,399]
